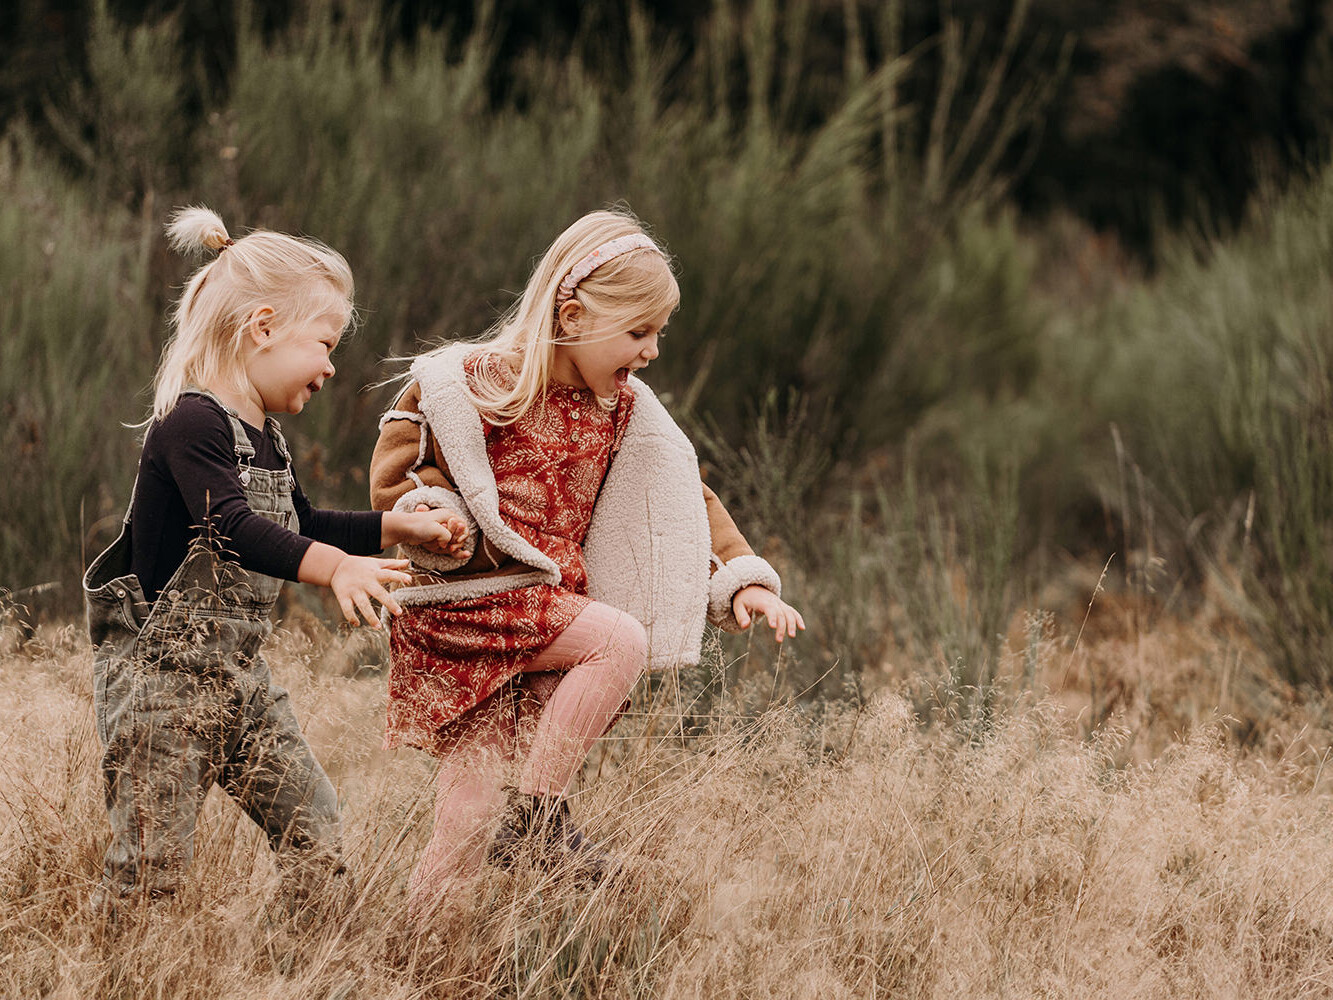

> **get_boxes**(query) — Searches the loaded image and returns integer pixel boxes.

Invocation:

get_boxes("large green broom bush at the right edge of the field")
[1066,160,1333,687]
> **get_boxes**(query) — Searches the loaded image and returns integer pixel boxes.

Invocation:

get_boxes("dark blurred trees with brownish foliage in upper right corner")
[1017,0,1333,252]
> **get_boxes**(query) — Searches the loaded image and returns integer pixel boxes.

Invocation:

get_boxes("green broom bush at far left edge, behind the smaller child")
[0,133,156,595]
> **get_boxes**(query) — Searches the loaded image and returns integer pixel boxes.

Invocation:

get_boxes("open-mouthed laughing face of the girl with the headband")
[552,301,674,399]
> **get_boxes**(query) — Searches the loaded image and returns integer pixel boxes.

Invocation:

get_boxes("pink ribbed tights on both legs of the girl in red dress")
[409,601,648,904]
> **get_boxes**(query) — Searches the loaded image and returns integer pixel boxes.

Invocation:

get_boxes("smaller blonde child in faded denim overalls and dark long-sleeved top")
[84,208,461,905]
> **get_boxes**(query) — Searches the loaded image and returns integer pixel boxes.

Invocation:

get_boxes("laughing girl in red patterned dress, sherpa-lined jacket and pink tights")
[371,212,805,904]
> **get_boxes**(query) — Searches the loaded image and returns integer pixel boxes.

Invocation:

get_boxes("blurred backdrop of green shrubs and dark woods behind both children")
[0,0,1333,703]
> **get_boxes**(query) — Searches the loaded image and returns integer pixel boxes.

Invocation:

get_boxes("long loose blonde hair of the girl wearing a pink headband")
[453,211,680,425]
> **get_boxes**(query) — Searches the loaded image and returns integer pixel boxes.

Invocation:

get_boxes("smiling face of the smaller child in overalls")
[245,311,347,413]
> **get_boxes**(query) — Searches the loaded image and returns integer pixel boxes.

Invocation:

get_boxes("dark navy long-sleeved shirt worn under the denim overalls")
[131,395,383,600]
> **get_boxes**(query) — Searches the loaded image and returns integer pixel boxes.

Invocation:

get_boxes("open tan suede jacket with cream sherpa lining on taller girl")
[371,344,781,669]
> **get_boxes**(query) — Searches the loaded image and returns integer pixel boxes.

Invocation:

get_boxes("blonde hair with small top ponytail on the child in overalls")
[153,205,356,420]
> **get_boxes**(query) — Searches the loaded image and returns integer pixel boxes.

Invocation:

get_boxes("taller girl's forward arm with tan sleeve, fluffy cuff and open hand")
[704,485,805,643]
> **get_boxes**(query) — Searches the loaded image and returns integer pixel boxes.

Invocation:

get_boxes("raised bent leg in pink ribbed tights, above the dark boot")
[519,603,648,795]
